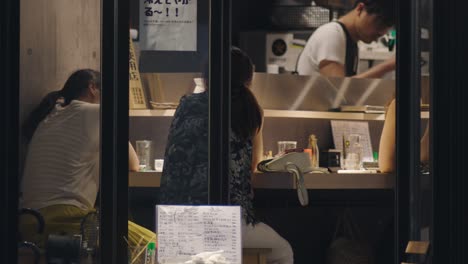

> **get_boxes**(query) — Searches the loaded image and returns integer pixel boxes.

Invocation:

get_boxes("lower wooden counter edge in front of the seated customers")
[128,172,395,190]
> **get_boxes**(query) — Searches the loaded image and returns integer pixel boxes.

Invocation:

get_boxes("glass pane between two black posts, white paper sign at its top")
[128,0,210,259]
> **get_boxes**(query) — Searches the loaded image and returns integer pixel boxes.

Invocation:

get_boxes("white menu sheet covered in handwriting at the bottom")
[156,205,242,264]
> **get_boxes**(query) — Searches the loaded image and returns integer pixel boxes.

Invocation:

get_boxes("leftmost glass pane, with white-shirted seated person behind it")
[19,0,101,263]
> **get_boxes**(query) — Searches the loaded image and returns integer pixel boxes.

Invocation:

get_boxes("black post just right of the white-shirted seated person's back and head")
[99,0,130,264]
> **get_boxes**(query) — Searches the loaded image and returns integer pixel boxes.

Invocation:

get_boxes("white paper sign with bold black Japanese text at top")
[140,0,197,51]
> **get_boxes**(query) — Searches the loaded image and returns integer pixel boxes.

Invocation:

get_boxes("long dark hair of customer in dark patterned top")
[203,47,263,140]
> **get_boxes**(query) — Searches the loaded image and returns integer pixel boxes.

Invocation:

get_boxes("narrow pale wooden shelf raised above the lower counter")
[129,109,429,120]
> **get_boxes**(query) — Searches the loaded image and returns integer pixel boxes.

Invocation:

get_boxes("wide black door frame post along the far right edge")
[431,0,468,263]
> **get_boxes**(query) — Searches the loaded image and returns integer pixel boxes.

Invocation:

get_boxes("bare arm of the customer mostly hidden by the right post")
[379,99,396,172]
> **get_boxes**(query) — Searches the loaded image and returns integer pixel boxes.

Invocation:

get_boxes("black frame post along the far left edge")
[0,0,20,263]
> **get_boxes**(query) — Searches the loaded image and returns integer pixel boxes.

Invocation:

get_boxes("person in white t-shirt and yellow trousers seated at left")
[20,69,155,251]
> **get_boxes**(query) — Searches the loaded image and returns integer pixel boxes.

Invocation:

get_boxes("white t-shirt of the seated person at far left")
[20,100,100,210]
